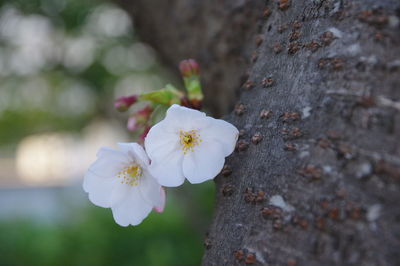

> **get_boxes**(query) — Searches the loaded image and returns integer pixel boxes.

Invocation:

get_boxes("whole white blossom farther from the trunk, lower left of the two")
[83,143,165,226]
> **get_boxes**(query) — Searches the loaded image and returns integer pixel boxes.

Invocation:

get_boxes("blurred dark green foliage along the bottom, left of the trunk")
[0,182,213,266]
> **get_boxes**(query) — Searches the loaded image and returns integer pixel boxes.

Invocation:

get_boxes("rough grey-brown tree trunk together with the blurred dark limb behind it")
[117,0,400,265]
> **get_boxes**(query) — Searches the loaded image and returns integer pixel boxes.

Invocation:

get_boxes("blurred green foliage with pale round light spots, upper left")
[0,0,171,147]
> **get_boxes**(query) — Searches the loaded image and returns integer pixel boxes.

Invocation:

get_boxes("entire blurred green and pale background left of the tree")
[0,0,214,266]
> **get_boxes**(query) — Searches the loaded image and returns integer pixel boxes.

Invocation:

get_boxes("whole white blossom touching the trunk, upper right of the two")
[144,104,239,187]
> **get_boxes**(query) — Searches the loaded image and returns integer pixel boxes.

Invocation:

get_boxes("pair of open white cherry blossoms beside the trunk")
[83,104,238,226]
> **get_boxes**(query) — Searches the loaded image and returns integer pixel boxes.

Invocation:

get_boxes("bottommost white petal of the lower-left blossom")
[111,191,153,226]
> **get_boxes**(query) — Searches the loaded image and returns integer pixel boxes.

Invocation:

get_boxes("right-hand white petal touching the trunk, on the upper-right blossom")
[199,117,239,157]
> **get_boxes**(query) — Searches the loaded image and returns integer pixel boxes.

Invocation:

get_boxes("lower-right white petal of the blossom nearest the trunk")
[183,141,225,184]
